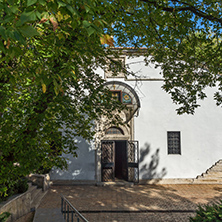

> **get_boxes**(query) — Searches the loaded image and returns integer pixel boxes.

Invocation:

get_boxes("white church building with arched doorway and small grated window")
[50,51,222,184]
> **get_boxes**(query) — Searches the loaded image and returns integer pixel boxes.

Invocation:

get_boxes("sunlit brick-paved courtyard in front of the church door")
[38,184,222,222]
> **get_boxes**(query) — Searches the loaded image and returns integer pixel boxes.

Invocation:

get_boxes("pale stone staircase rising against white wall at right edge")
[193,160,222,184]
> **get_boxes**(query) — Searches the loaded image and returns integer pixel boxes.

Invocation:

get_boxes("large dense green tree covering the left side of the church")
[0,1,123,196]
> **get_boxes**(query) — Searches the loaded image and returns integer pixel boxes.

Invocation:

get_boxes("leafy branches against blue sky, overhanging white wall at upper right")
[109,0,222,114]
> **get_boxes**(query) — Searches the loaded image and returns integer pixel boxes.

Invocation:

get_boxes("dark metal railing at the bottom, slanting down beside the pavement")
[61,195,89,222]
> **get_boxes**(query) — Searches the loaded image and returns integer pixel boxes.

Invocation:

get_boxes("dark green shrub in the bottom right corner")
[190,201,222,222]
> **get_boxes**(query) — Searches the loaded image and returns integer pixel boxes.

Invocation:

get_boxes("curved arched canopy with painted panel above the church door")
[104,81,140,122]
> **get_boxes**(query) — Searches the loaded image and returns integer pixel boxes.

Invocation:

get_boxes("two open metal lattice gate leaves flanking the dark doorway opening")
[101,140,139,183]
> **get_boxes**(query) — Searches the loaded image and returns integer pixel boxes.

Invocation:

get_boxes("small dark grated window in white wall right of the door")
[167,132,181,154]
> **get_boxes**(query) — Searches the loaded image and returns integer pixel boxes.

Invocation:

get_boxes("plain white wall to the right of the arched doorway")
[123,58,222,179]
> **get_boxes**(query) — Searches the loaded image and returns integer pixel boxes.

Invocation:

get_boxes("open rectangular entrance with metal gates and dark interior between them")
[101,140,139,182]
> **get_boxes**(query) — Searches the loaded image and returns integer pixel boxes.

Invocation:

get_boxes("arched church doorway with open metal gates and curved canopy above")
[97,81,140,182]
